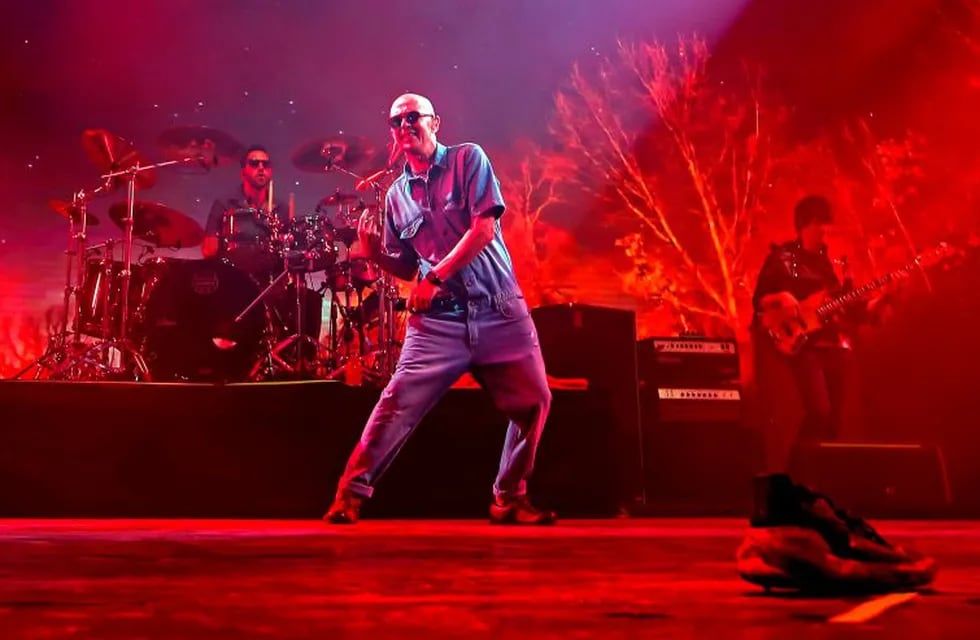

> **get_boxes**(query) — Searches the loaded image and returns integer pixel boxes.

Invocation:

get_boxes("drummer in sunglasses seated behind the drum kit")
[201,145,288,280]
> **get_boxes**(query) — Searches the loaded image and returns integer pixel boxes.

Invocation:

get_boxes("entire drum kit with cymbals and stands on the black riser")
[15,127,405,384]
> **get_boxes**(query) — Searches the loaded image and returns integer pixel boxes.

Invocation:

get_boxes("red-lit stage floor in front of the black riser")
[0,519,980,640]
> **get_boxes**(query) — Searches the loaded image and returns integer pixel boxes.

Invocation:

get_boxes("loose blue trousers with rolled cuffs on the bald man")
[338,296,551,499]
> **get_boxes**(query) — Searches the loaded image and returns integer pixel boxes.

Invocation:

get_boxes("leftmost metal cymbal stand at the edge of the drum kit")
[13,180,110,380]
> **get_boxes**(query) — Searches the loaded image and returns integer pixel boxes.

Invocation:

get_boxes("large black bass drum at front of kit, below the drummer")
[143,259,265,382]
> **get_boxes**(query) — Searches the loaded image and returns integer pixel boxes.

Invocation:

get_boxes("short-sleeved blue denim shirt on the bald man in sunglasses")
[382,143,521,302]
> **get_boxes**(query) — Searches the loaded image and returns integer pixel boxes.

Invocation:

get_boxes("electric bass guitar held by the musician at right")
[759,242,960,355]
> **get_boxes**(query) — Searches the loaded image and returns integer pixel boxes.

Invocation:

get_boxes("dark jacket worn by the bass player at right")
[752,240,850,347]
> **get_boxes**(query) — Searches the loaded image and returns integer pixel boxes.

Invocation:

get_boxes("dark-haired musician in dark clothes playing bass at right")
[752,195,884,470]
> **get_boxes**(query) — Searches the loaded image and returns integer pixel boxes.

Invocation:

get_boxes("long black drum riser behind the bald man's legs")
[0,381,618,518]
